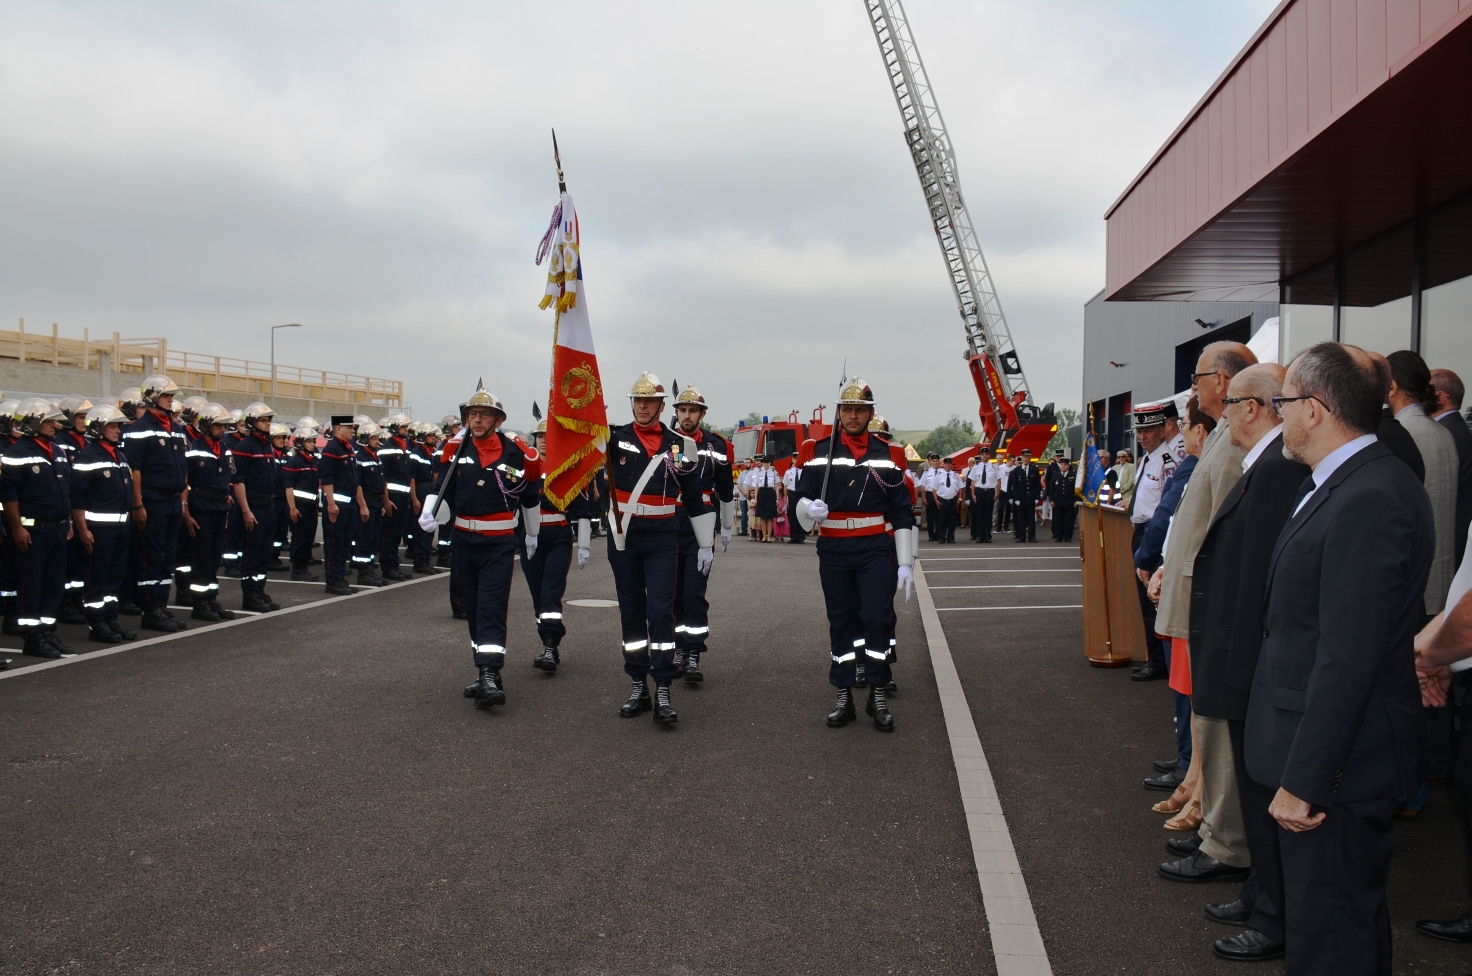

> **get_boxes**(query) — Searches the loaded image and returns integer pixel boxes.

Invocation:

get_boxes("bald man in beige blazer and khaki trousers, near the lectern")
[1156,342,1257,883]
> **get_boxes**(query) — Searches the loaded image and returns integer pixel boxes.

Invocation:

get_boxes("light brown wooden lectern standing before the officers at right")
[1079,505,1147,668]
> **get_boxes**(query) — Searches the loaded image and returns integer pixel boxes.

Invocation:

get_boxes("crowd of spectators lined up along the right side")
[1110,342,1472,975]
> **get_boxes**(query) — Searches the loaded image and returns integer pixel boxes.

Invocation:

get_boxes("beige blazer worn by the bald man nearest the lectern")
[1156,418,1242,639]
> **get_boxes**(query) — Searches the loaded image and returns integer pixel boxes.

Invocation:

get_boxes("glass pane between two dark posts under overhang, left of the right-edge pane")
[1340,227,1415,355]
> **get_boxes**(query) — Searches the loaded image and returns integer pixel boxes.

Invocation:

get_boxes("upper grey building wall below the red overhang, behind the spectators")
[1083,291,1278,403]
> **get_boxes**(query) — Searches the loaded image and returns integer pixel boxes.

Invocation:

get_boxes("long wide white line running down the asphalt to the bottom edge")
[916,565,1052,976]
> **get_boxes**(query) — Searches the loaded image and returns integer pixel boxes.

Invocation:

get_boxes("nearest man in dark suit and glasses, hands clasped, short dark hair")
[1242,342,1435,976]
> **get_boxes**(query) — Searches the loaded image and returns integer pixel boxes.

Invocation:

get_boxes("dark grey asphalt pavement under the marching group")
[0,528,1472,975]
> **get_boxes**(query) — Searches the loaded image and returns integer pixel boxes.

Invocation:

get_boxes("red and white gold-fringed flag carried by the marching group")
[537,190,608,511]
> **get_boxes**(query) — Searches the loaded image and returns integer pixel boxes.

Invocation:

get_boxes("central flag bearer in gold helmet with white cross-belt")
[608,372,715,724]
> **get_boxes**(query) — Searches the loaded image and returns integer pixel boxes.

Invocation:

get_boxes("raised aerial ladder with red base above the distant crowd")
[864,0,1058,458]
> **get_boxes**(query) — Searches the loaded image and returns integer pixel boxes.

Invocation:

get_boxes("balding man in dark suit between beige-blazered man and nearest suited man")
[1183,362,1309,960]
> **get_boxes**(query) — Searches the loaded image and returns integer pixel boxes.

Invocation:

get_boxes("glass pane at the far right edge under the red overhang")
[1420,202,1472,394]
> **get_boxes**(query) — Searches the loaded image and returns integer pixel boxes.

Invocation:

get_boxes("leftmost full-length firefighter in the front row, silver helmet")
[0,397,74,658]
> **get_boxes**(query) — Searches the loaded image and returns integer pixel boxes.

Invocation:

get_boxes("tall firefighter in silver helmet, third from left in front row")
[122,375,188,633]
